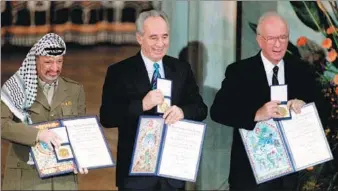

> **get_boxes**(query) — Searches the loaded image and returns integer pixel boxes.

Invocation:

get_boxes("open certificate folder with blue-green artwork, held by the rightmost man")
[239,103,333,184]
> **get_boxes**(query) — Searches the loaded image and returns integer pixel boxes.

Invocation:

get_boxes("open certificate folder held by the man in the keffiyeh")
[32,116,115,178]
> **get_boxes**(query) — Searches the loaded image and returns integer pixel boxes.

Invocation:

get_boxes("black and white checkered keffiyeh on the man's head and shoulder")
[1,33,66,124]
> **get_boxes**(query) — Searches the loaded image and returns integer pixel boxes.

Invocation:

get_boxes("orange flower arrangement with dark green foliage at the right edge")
[290,0,338,191]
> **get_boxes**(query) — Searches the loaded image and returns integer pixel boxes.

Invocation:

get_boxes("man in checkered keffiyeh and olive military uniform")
[1,33,88,190]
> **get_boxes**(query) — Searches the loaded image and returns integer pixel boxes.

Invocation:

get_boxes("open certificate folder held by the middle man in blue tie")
[129,116,206,182]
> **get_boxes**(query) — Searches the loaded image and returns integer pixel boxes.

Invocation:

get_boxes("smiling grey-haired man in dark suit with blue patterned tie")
[100,10,208,190]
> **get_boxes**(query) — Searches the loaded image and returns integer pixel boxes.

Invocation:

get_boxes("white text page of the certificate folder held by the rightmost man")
[280,103,333,171]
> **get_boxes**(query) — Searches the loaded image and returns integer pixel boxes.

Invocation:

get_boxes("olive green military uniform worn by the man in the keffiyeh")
[1,77,86,190]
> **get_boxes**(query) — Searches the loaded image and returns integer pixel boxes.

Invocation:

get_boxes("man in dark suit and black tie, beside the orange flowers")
[210,12,329,191]
